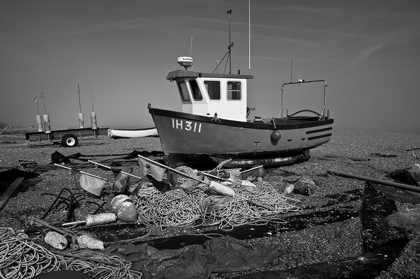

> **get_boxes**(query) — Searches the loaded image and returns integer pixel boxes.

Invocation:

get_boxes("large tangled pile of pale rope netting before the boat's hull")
[133,166,299,230]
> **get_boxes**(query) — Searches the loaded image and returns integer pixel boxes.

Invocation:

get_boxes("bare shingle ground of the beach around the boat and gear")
[0,131,420,279]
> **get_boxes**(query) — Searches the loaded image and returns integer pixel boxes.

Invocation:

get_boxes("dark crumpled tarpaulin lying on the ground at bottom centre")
[106,236,280,279]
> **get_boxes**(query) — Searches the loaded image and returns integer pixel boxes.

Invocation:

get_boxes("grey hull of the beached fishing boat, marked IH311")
[149,107,334,163]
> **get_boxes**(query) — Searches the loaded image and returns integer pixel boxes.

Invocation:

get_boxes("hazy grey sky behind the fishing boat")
[0,0,420,134]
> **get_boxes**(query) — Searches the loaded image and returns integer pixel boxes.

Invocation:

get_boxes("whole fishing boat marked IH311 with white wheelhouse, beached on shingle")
[148,57,334,167]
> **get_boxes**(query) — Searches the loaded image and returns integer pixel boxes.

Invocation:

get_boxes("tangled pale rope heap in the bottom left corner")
[0,227,142,279]
